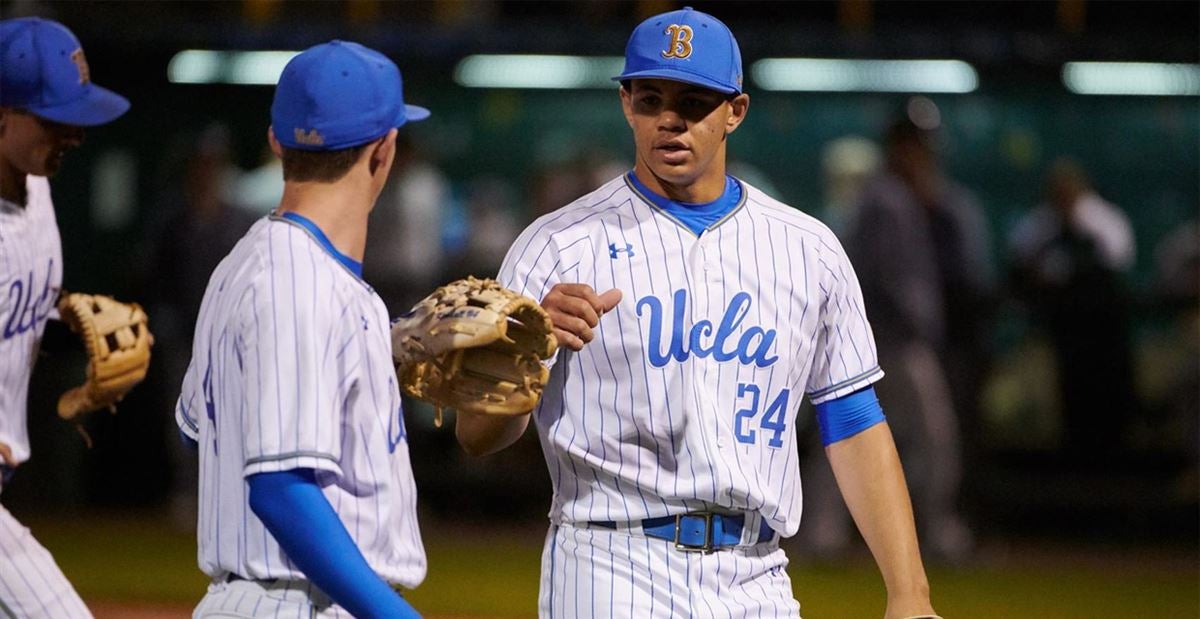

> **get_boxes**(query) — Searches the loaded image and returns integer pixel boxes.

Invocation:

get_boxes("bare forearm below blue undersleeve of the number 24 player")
[826,423,934,619]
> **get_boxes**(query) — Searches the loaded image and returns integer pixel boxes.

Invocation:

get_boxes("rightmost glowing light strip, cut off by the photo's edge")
[1062,62,1200,96]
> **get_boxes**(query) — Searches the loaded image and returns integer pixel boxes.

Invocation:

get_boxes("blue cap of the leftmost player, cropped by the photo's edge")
[0,17,130,127]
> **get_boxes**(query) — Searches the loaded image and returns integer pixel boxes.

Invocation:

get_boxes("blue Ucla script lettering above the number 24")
[637,288,779,367]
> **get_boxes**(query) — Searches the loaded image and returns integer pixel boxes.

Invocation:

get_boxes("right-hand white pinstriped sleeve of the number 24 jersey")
[806,238,883,404]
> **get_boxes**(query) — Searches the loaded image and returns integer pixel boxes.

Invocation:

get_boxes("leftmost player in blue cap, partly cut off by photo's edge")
[0,18,130,618]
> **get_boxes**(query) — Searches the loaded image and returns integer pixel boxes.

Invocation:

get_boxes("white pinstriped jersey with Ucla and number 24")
[499,176,883,536]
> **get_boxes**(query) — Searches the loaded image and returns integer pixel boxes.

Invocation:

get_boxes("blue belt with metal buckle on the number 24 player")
[588,511,775,552]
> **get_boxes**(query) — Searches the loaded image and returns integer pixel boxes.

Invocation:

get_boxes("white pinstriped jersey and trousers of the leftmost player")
[0,176,91,619]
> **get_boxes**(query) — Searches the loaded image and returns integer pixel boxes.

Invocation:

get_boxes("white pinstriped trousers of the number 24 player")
[538,524,800,619]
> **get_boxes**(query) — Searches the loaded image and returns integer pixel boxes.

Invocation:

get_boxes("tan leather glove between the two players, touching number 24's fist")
[391,277,558,426]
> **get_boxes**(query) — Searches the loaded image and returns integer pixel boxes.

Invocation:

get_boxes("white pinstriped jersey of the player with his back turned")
[175,216,426,588]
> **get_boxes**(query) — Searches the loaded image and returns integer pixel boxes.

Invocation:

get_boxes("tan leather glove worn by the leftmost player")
[59,293,154,420]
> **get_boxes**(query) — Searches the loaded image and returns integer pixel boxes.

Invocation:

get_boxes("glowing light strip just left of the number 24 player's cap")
[454,54,625,89]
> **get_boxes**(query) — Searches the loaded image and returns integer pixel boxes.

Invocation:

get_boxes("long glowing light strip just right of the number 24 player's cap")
[750,58,979,94]
